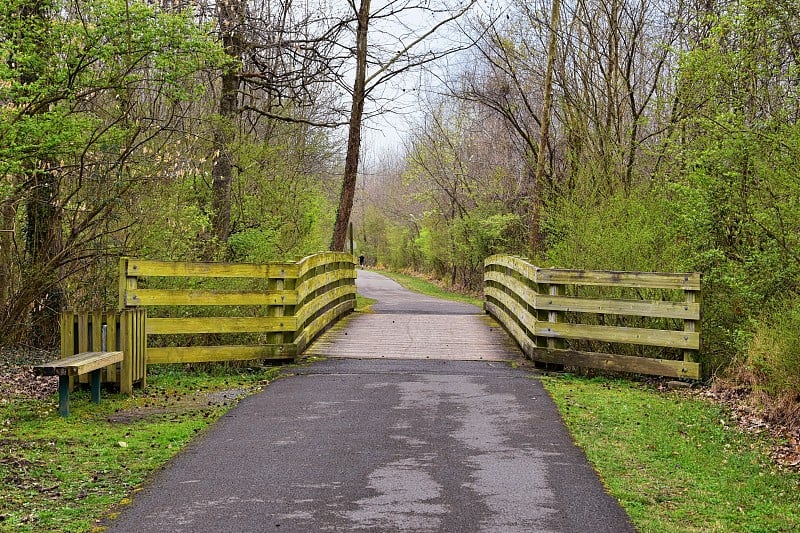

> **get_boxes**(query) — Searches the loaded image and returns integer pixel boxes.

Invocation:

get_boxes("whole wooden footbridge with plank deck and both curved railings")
[62,252,702,392]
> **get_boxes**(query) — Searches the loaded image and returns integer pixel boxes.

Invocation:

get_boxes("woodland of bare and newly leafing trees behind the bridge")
[0,0,800,416]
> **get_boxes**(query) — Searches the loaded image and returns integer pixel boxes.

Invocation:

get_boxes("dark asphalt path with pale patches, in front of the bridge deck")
[110,272,633,533]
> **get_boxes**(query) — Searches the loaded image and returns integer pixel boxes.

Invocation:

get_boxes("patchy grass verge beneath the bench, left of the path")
[0,368,279,532]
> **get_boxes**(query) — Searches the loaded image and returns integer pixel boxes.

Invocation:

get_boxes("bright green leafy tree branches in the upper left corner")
[0,0,224,174]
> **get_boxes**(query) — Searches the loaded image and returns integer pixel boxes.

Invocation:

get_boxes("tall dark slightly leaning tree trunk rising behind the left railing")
[331,0,370,252]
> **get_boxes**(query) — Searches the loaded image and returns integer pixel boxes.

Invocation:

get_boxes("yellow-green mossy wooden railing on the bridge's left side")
[120,252,356,364]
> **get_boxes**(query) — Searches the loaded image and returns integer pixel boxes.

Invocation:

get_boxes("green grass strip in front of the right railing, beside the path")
[542,376,800,532]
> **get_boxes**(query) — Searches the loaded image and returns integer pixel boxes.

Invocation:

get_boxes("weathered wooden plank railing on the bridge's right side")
[484,255,702,379]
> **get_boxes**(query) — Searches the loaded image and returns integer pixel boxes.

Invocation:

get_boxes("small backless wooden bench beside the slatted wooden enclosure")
[33,352,122,416]
